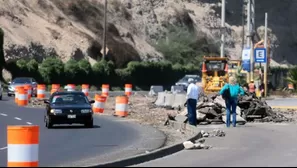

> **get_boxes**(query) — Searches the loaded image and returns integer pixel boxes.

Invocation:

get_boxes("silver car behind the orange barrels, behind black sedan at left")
[7,77,37,97]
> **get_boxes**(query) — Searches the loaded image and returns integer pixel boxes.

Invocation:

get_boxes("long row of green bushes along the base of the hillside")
[7,57,200,89]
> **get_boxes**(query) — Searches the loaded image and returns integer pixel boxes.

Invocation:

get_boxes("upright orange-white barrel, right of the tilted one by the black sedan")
[115,96,129,117]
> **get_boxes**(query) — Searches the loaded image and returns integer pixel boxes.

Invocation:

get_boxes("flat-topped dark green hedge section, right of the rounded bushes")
[116,62,200,89]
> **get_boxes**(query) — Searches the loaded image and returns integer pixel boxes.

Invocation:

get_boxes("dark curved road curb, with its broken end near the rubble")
[88,121,202,167]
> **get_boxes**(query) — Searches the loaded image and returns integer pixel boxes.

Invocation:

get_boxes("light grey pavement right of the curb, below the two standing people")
[136,124,297,167]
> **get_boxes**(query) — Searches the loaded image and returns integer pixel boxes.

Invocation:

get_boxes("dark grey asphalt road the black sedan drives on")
[0,94,165,167]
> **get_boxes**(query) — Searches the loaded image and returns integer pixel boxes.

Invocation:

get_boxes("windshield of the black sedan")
[51,94,89,104]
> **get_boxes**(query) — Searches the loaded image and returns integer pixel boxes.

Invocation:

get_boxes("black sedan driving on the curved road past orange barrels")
[44,91,94,128]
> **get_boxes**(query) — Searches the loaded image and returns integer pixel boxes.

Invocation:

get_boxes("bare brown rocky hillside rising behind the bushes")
[0,0,297,66]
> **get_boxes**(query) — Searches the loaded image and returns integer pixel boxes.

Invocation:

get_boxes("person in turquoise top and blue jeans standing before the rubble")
[219,76,244,127]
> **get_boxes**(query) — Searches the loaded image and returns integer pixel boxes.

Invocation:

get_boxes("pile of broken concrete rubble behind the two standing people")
[175,94,290,125]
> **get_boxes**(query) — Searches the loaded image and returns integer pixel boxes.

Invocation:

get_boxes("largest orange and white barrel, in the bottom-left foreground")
[7,125,39,167]
